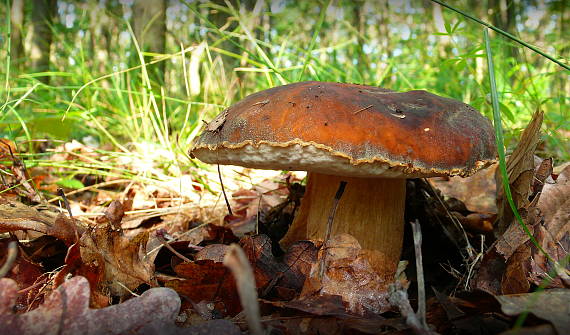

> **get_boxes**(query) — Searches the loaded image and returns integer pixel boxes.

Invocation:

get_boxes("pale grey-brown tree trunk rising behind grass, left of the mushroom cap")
[133,0,167,85]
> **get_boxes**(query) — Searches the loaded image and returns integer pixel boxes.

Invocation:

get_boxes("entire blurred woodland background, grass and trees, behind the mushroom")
[0,0,570,176]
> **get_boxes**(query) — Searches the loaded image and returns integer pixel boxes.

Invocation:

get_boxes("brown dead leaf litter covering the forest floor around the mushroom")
[0,113,570,334]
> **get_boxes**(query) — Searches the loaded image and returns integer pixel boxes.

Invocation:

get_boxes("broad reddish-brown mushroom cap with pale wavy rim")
[191,81,496,178]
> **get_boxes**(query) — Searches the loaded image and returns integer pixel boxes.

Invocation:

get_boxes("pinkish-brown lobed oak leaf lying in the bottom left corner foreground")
[0,277,240,335]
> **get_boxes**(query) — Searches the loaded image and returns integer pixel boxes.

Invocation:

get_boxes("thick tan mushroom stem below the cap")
[281,172,406,282]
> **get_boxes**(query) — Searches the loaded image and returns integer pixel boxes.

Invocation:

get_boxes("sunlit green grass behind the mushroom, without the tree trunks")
[0,1,570,184]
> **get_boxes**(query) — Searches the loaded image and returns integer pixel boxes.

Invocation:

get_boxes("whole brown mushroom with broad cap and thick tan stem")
[191,81,496,281]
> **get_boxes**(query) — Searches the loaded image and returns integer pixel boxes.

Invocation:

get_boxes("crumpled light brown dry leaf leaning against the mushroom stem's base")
[300,234,390,315]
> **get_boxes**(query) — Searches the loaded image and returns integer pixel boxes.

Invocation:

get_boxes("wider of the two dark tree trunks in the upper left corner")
[30,0,57,83]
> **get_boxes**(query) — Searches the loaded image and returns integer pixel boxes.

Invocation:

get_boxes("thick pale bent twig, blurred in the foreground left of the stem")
[224,243,265,335]
